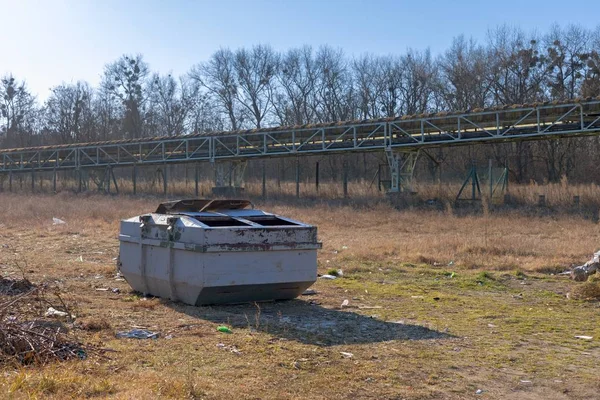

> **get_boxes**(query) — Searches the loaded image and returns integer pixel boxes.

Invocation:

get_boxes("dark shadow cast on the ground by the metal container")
[167,299,452,346]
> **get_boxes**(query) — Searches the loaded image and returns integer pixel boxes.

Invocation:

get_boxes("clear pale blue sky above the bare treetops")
[0,0,600,100]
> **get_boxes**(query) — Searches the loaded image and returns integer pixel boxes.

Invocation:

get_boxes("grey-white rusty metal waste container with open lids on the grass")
[119,200,321,305]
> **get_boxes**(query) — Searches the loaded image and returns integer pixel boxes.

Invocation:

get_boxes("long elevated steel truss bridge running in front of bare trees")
[0,99,600,190]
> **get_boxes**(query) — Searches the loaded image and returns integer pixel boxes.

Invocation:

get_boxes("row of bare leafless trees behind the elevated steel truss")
[0,25,600,182]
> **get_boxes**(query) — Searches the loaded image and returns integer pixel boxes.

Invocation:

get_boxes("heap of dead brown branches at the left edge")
[0,279,89,365]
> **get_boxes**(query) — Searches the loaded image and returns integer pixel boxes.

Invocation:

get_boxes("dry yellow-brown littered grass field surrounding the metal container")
[0,193,600,400]
